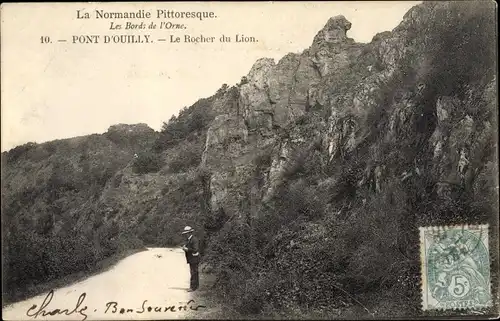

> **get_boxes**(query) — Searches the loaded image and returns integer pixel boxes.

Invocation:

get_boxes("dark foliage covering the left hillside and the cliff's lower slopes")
[2,2,498,317]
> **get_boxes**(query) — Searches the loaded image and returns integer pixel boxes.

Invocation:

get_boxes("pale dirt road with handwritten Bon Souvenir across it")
[2,248,208,320]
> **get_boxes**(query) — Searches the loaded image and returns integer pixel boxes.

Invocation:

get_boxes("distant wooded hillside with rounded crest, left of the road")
[2,124,158,301]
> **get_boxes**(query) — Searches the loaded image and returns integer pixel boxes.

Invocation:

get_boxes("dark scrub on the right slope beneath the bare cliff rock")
[202,4,498,317]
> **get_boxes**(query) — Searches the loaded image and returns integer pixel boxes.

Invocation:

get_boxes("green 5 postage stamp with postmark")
[420,225,492,310]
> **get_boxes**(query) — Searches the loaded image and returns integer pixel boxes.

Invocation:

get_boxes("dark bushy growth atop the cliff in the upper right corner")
[420,2,496,96]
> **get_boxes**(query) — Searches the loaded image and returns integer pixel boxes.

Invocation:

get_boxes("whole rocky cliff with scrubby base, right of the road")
[190,2,498,316]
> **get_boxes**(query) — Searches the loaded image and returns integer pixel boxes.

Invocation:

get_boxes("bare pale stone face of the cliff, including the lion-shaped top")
[197,3,496,228]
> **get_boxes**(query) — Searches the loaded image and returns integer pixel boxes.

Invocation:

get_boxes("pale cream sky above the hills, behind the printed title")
[1,1,420,152]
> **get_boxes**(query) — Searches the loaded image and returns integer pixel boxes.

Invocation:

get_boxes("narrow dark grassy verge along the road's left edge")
[2,247,147,308]
